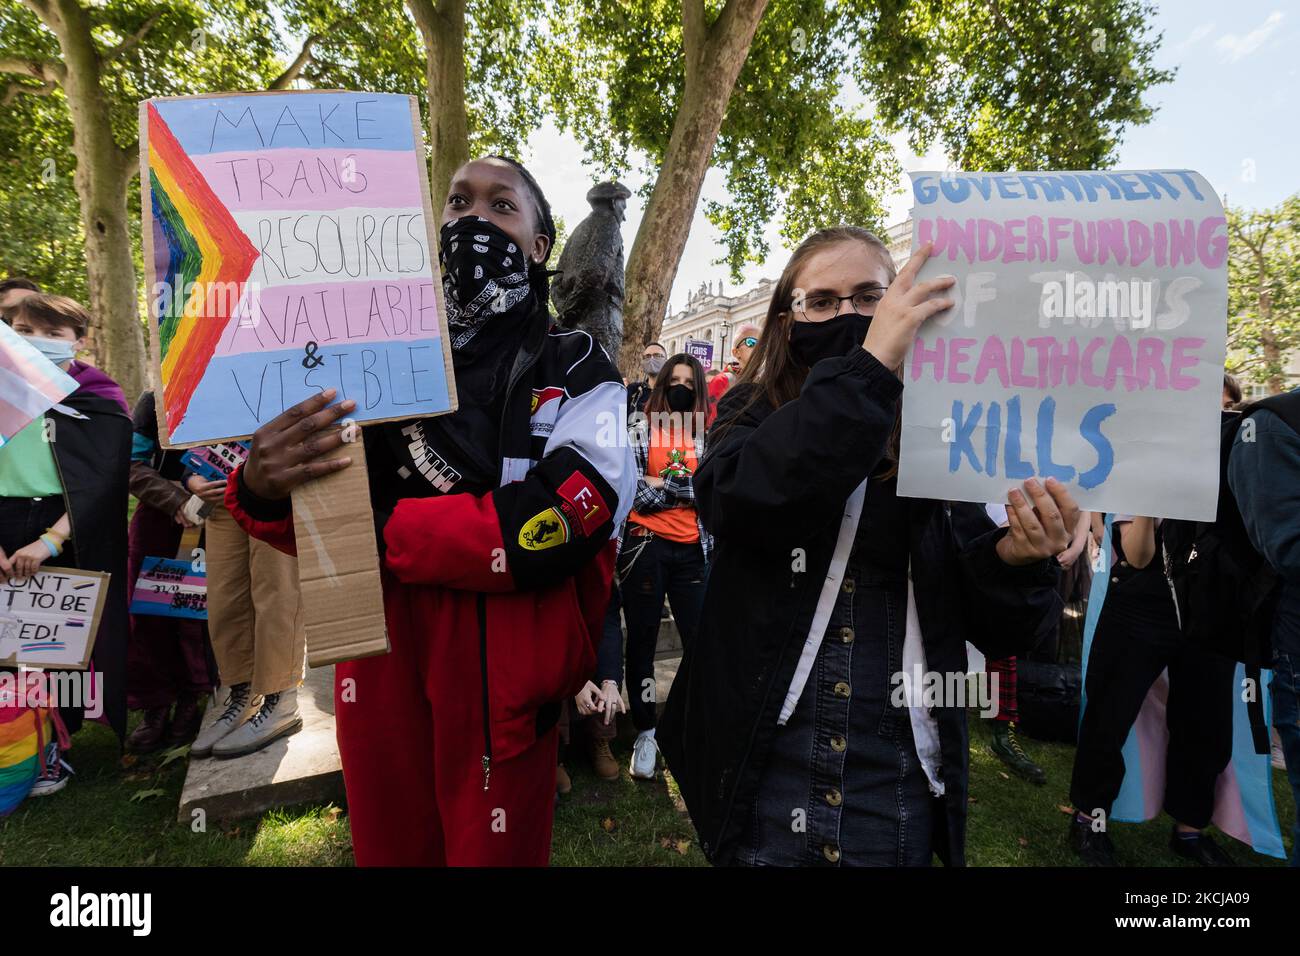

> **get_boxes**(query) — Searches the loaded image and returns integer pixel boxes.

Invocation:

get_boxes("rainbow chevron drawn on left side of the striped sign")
[148,103,257,432]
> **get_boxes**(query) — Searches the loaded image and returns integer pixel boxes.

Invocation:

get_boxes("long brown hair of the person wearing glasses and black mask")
[711,225,902,477]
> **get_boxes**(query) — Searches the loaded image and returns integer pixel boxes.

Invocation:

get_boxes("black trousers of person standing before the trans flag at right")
[1070,576,1236,827]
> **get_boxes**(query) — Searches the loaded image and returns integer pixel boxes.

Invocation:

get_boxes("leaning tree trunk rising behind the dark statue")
[619,0,767,377]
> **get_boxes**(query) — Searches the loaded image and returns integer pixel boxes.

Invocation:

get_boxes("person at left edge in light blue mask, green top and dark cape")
[0,293,131,795]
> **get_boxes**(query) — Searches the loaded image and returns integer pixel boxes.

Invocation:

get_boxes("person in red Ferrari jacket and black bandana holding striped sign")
[226,156,636,866]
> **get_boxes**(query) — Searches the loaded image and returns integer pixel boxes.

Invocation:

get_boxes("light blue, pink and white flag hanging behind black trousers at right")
[1079,515,1286,860]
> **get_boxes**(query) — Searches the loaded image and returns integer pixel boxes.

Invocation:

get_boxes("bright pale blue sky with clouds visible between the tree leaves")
[527,0,1300,311]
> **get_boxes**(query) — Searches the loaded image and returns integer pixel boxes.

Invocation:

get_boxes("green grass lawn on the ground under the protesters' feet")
[0,718,1295,866]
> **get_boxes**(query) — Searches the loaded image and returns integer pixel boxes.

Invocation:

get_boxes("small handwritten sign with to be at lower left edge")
[0,564,109,670]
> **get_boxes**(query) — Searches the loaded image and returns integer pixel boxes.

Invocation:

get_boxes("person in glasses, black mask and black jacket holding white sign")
[658,226,1078,866]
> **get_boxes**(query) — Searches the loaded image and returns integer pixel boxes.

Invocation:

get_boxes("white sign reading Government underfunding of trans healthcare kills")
[898,170,1227,520]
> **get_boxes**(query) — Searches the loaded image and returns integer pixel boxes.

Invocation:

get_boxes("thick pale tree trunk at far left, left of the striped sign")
[46,0,147,401]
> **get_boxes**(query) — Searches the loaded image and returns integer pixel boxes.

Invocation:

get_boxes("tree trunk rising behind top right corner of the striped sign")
[407,0,469,200]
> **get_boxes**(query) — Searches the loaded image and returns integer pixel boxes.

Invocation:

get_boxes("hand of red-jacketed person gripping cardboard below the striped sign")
[244,389,356,499]
